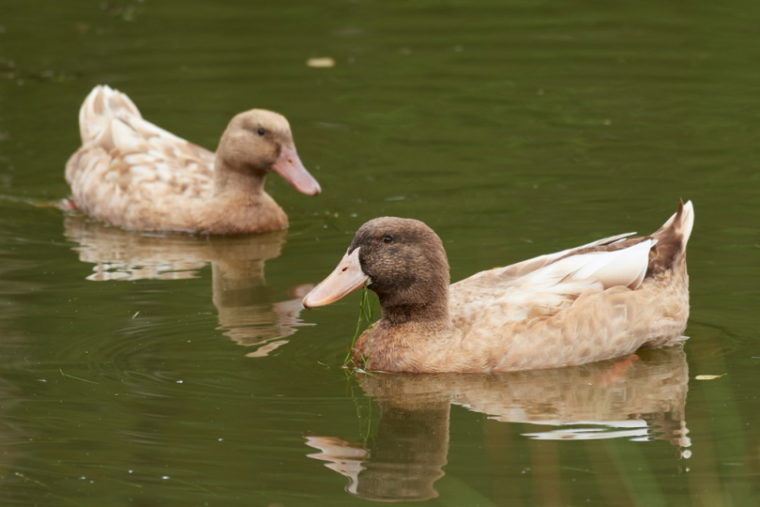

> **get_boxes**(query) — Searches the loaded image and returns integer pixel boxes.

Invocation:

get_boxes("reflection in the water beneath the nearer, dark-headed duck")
[306,346,691,501]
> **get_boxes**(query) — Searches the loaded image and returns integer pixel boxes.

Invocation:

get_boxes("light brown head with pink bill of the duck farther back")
[216,109,321,195]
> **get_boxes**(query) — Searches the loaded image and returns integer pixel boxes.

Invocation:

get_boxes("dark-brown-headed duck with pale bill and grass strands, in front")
[302,201,694,373]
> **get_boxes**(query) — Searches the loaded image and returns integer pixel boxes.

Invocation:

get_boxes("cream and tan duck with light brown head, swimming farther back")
[65,85,321,235]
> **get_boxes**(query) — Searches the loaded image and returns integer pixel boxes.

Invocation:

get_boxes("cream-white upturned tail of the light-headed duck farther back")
[79,85,142,144]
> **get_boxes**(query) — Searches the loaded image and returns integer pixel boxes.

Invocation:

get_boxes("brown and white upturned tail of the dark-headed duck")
[647,201,694,276]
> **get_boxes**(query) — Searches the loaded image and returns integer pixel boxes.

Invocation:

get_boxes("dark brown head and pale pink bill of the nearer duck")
[303,217,449,320]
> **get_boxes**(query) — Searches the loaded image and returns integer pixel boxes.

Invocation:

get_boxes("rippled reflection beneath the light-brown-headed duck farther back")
[64,215,312,357]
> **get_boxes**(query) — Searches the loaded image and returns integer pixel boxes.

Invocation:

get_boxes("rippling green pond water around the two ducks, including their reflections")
[0,0,760,506]
